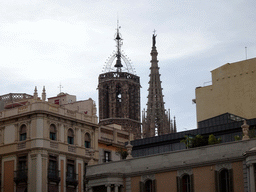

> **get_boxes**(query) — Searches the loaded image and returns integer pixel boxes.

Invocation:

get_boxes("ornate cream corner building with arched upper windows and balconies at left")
[0,89,99,192]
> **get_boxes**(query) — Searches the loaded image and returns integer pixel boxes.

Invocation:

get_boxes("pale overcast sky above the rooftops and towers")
[0,0,256,131]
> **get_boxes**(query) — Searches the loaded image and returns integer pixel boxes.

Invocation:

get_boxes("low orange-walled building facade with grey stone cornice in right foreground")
[86,132,256,192]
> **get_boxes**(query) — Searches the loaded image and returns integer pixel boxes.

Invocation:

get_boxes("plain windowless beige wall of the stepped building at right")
[196,58,256,122]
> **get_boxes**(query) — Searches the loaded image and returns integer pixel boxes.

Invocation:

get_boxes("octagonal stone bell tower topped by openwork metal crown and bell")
[98,24,141,139]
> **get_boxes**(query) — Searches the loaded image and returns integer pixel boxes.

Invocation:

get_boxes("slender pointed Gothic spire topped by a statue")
[142,34,176,138]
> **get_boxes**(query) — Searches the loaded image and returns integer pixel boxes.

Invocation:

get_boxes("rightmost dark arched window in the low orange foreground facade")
[215,168,233,192]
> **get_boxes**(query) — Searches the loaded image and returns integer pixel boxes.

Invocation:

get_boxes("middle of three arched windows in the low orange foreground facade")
[177,173,194,192]
